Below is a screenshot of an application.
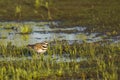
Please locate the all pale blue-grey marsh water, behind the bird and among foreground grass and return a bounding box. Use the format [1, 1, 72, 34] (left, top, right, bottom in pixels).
[0, 21, 120, 62]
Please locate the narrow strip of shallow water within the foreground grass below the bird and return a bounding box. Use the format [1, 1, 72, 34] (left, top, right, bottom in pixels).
[0, 55, 87, 63]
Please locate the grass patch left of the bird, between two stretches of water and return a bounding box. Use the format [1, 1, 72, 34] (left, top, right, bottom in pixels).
[0, 42, 29, 57]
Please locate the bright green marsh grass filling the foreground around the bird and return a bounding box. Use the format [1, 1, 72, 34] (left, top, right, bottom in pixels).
[0, 41, 120, 80]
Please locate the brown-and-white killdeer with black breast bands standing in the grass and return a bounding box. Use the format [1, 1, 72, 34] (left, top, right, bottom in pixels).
[27, 42, 48, 53]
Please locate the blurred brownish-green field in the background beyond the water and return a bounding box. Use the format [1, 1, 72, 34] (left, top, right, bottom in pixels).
[0, 0, 120, 35]
